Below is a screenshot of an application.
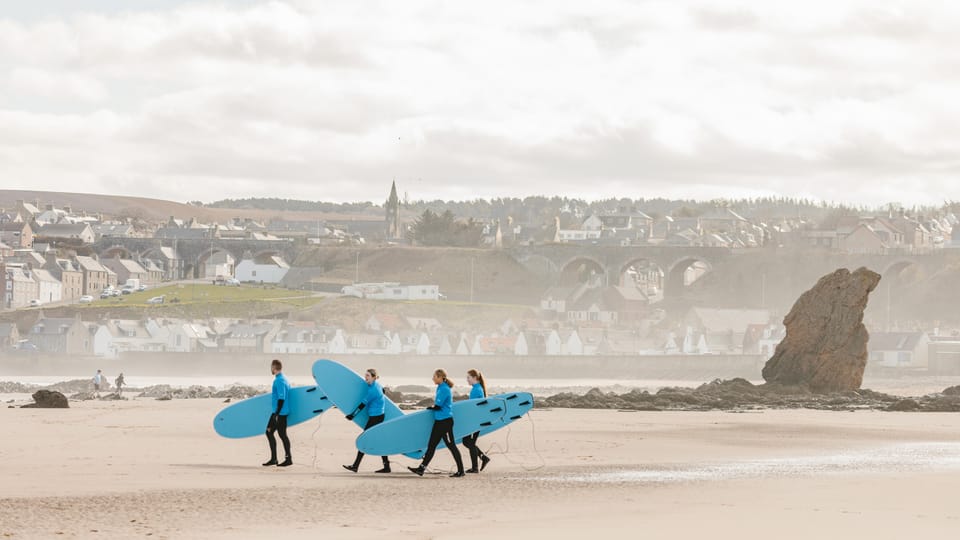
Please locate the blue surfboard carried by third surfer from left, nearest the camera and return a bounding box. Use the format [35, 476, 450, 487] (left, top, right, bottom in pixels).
[357, 397, 507, 456]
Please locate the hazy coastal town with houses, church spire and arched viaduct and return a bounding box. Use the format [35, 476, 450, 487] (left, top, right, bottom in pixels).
[0, 184, 960, 374]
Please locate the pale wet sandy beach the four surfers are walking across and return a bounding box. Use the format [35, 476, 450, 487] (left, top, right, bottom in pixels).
[0, 399, 960, 538]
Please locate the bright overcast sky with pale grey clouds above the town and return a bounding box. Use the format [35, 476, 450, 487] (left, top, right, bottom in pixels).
[0, 0, 960, 205]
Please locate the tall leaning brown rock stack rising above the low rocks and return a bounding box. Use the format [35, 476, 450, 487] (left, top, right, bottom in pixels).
[763, 268, 880, 393]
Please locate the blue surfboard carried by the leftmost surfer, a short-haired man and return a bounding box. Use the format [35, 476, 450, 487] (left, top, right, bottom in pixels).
[213, 386, 333, 439]
